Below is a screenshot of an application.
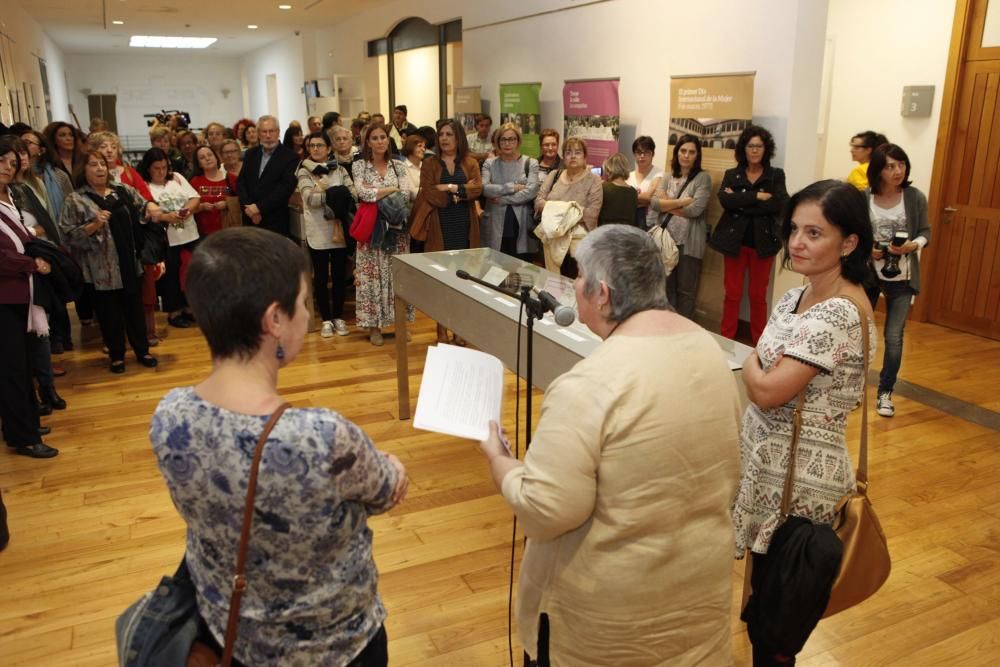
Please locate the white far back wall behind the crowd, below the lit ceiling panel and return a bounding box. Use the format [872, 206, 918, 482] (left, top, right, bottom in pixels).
[67, 49, 243, 138]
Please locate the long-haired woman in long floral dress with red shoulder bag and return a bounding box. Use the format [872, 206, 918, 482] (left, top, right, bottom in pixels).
[352, 124, 415, 345]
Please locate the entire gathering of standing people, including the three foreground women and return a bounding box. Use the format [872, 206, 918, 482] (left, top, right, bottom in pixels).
[0, 100, 930, 664]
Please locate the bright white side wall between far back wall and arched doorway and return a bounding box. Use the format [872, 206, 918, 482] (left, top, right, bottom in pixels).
[242, 35, 304, 131]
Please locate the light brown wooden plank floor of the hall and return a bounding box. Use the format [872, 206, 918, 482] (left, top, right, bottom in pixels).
[0, 316, 1000, 667]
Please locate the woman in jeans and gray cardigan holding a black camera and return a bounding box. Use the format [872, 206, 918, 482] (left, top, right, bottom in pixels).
[865, 143, 931, 417]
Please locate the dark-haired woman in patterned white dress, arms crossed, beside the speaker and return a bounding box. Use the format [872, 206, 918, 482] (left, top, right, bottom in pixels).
[732, 181, 875, 665]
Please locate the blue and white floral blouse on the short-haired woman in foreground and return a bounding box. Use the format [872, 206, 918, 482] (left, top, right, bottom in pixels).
[149, 387, 396, 667]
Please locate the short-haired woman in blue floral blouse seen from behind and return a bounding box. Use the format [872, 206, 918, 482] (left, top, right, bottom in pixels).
[150, 227, 408, 667]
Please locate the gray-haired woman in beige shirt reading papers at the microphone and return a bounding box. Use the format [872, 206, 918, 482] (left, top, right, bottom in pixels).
[481, 225, 740, 666]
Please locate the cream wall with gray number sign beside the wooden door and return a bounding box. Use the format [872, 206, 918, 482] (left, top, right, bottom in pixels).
[823, 0, 952, 193]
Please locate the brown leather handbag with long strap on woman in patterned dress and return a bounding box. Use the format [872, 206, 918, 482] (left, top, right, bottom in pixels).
[823, 297, 892, 618]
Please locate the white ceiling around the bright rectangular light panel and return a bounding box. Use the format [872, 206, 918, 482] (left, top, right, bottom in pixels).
[19, 0, 374, 56]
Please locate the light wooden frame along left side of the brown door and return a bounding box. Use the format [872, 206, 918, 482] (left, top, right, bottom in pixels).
[913, 0, 1000, 322]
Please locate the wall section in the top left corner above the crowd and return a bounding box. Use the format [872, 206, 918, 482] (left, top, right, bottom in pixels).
[0, 3, 70, 128]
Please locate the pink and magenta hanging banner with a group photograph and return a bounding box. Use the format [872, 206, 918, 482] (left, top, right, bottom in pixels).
[563, 79, 621, 167]
